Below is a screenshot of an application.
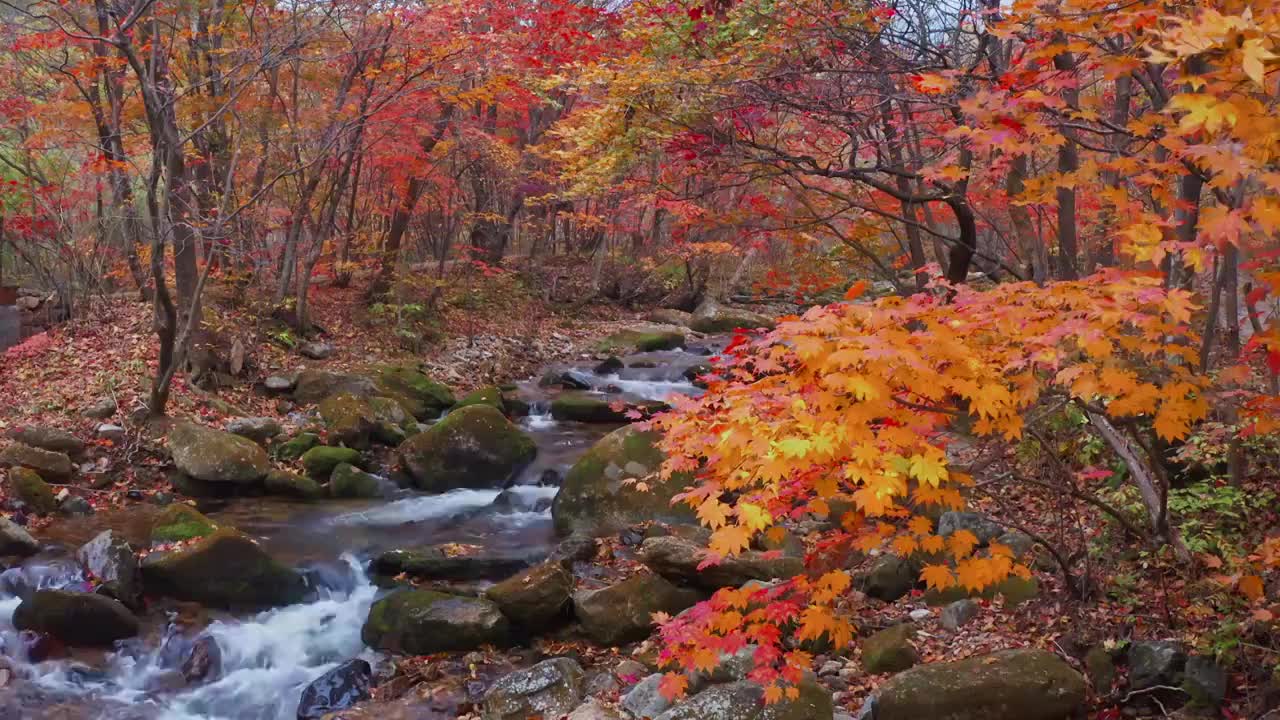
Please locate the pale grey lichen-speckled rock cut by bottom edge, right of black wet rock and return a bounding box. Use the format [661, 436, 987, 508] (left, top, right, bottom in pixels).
[480, 657, 584, 720]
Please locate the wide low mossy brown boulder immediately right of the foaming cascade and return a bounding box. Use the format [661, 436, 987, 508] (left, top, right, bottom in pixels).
[360, 589, 511, 655]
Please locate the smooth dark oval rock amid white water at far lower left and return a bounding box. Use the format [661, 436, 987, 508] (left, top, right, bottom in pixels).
[13, 591, 138, 647]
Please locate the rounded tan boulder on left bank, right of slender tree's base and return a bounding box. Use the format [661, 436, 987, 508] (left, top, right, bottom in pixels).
[169, 423, 271, 484]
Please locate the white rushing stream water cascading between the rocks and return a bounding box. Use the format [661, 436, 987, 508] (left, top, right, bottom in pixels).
[0, 338, 710, 720]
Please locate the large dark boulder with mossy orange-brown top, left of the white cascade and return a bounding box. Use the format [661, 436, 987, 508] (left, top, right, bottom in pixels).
[142, 528, 307, 610]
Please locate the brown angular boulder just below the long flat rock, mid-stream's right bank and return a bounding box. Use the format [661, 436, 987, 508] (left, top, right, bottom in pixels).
[573, 573, 703, 646]
